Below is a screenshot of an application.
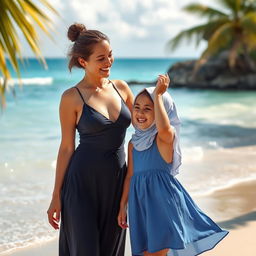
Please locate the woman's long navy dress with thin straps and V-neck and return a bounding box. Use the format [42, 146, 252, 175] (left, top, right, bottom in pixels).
[59, 83, 131, 256]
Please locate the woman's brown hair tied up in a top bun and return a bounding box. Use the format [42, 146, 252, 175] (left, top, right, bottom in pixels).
[67, 23, 109, 71]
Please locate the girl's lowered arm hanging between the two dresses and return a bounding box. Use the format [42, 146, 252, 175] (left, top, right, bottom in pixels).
[117, 142, 133, 228]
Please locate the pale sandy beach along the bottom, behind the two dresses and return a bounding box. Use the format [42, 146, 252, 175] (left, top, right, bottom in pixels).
[1, 178, 256, 256]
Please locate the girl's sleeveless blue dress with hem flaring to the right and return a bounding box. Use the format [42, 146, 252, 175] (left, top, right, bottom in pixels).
[128, 139, 228, 256]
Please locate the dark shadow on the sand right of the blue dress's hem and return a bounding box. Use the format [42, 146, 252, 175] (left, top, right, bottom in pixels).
[218, 211, 256, 230]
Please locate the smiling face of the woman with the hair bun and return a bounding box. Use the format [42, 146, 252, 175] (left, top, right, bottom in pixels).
[85, 40, 114, 78]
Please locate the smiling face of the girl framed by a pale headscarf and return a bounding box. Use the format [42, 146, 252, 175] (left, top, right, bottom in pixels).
[132, 94, 155, 130]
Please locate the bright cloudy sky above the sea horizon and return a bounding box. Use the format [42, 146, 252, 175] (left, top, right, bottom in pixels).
[21, 0, 219, 58]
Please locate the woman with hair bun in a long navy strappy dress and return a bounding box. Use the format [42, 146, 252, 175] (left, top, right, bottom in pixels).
[47, 24, 133, 256]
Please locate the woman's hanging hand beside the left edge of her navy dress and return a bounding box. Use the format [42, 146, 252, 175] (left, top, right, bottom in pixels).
[47, 196, 61, 229]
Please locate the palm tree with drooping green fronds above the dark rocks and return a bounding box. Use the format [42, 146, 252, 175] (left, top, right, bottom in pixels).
[167, 0, 256, 71]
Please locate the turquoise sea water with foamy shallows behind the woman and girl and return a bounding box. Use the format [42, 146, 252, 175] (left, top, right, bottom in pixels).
[0, 59, 256, 254]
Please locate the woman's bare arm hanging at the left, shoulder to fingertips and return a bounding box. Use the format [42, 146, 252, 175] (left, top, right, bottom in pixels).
[47, 89, 76, 229]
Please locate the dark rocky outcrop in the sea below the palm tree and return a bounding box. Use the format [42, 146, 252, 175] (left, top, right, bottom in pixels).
[168, 54, 256, 90]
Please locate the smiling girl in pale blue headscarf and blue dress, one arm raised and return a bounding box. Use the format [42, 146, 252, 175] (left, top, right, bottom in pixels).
[118, 75, 228, 256]
